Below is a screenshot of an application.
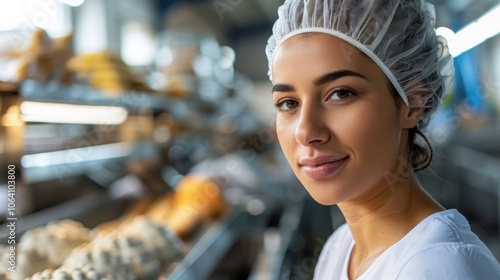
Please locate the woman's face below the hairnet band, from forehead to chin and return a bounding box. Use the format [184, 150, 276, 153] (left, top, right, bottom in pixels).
[273, 33, 407, 205]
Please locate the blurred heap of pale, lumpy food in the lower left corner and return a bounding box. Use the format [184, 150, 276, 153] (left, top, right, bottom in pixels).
[0, 216, 184, 280]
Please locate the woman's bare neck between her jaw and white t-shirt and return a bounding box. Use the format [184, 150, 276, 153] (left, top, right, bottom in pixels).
[338, 175, 444, 276]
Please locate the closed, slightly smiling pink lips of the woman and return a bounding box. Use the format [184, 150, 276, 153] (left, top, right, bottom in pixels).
[299, 156, 349, 180]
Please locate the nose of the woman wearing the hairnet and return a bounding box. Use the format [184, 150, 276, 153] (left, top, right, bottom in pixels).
[295, 104, 330, 146]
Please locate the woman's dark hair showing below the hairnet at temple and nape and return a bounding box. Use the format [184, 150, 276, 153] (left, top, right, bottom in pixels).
[388, 81, 434, 172]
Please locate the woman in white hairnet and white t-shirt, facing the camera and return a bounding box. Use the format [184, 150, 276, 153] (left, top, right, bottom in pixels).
[266, 0, 500, 280]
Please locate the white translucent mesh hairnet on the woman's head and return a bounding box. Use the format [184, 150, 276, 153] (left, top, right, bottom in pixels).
[266, 0, 454, 129]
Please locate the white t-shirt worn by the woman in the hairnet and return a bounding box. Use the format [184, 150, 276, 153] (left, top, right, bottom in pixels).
[314, 210, 500, 280]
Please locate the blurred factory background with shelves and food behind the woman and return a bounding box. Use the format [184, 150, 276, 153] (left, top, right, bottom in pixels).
[0, 0, 500, 279]
